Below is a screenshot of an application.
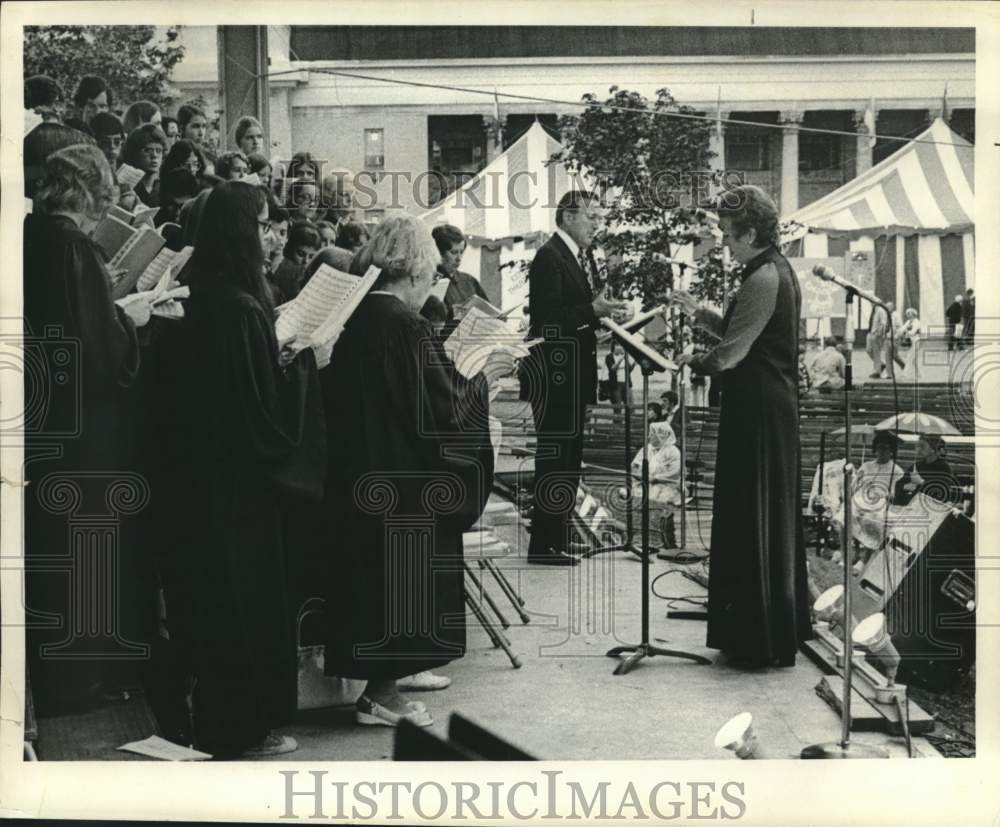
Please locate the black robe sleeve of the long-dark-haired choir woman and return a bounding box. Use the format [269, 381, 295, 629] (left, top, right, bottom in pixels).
[217, 303, 326, 500]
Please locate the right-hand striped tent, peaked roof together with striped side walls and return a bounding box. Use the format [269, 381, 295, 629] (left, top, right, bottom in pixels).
[784, 118, 975, 330]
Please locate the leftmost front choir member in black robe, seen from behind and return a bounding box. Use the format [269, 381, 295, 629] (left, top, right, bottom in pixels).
[23, 142, 156, 715]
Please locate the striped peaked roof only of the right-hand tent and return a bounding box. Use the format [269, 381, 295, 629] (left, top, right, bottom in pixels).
[785, 118, 975, 237]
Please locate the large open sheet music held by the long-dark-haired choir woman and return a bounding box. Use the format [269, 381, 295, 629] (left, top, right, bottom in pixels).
[274, 264, 379, 344]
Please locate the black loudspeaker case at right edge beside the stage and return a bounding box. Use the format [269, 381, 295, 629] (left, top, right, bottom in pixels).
[876, 504, 976, 689]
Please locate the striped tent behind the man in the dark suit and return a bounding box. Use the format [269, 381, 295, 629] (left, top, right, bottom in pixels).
[421, 121, 581, 309]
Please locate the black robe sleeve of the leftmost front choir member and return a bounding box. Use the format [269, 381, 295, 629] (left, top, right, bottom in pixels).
[61, 236, 139, 392]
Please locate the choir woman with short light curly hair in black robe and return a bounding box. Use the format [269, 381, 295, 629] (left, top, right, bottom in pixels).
[320, 215, 493, 725]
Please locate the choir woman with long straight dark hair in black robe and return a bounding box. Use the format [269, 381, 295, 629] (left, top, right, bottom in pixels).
[166, 181, 326, 758]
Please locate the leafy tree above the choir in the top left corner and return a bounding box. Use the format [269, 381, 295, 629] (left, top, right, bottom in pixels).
[24, 26, 184, 111]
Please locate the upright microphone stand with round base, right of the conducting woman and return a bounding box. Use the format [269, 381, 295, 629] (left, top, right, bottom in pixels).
[800, 288, 889, 758]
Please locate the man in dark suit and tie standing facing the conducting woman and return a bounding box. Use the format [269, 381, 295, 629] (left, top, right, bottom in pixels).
[528, 191, 627, 565]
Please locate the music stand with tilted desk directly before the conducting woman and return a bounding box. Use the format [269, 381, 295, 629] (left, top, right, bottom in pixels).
[603, 319, 711, 675]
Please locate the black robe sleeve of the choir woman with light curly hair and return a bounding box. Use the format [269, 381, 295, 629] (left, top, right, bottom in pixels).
[384, 318, 493, 530]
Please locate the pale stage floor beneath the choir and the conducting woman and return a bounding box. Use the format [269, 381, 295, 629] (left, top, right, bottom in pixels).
[278, 512, 939, 761]
